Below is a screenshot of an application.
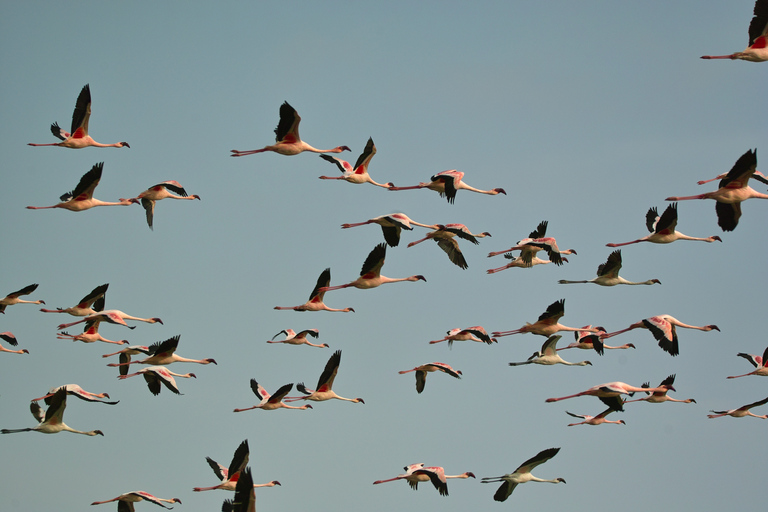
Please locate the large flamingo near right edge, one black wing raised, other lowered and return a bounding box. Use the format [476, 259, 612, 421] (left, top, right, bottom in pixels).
[666, 149, 768, 231]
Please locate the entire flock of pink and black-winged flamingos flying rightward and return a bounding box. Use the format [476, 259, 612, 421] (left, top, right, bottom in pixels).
[0, 0, 768, 512]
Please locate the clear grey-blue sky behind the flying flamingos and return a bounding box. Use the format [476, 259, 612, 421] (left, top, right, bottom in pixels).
[0, 0, 768, 512]
